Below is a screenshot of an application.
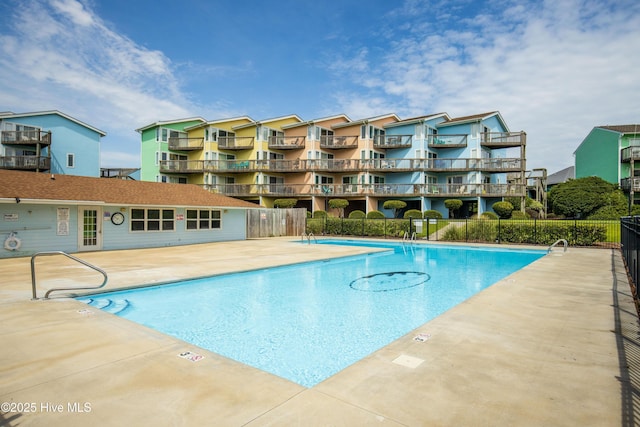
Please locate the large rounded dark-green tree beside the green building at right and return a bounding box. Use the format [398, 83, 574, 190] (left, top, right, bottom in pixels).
[548, 176, 626, 218]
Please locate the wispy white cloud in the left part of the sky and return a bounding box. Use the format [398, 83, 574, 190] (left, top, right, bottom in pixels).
[0, 0, 197, 167]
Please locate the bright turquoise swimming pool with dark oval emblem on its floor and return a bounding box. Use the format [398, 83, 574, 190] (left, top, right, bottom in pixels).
[78, 240, 546, 387]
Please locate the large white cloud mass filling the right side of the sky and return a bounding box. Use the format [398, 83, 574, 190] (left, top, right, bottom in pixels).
[339, 0, 640, 173]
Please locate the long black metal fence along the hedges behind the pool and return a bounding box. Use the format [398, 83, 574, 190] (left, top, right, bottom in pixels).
[306, 217, 620, 248]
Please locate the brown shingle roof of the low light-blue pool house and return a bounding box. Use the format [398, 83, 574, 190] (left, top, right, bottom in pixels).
[0, 169, 259, 208]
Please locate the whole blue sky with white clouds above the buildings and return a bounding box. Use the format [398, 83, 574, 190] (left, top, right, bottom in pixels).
[0, 0, 640, 173]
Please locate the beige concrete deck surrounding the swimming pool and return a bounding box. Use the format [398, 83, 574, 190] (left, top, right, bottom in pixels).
[0, 238, 640, 426]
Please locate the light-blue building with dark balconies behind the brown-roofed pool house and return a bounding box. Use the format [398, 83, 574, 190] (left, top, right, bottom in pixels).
[0, 110, 106, 177]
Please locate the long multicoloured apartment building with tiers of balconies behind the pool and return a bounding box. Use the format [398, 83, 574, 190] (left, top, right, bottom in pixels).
[138, 111, 526, 216]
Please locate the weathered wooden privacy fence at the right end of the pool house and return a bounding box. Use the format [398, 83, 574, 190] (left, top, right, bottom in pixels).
[247, 208, 307, 239]
